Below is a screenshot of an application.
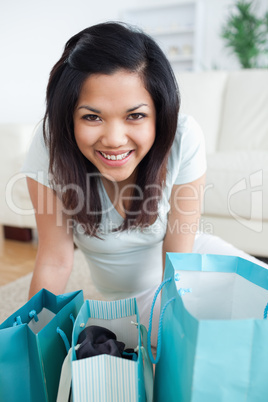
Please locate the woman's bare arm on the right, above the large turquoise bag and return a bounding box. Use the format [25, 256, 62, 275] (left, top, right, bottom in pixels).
[163, 175, 205, 267]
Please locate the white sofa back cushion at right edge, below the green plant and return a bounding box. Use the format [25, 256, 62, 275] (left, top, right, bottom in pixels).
[219, 70, 268, 151]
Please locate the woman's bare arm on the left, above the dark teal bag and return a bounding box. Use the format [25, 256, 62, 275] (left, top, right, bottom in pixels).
[27, 178, 74, 297]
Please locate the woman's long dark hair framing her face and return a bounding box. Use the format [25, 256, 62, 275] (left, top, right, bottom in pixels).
[43, 22, 180, 237]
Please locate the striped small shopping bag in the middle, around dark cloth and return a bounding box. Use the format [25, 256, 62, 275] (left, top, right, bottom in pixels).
[57, 298, 153, 402]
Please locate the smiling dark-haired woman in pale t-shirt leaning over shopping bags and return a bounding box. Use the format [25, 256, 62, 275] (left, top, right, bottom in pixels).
[23, 23, 264, 346]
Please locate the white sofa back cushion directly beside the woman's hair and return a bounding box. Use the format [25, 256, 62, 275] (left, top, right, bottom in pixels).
[176, 71, 227, 154]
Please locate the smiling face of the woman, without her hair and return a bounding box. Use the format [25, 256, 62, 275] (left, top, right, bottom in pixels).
[73, 70, 156, 183]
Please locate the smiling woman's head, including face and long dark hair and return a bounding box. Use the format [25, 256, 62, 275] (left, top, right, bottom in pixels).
[39, 23, 179, 236]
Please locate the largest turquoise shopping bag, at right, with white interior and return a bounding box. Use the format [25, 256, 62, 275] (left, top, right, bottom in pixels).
[148, 253, 268, 402]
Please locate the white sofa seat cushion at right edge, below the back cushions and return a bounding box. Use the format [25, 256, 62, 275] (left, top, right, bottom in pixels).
[203, 151, 268, 221]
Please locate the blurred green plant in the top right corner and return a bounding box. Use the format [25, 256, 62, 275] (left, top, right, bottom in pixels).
[221, 0, 268, 68]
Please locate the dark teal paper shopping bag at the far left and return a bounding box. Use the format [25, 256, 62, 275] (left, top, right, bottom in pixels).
[0, 289, 83, 402]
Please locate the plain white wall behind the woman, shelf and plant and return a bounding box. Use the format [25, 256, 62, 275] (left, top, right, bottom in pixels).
[0, 0, 268, 123]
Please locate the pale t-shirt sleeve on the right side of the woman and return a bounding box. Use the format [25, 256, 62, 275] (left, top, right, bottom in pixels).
[171, 116, 207, 185]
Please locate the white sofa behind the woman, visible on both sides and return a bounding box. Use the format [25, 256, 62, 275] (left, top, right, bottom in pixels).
[0, 70, 268, 257]
